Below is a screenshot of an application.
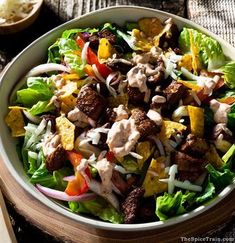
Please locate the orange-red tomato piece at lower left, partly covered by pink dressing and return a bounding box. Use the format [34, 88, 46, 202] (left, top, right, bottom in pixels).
[65, 151, 91, 196]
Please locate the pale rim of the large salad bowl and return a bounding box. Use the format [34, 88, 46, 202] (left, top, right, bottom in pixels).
[0, 5, 235, 232]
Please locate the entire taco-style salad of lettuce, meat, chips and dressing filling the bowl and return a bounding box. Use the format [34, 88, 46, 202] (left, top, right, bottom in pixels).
[5, 17, 235, 224]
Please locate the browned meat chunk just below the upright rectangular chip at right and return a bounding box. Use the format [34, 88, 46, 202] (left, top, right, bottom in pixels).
[180, 134, 209, 157]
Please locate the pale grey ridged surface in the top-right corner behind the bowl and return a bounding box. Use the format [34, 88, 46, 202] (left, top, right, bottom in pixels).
[187, 0, 235, 47]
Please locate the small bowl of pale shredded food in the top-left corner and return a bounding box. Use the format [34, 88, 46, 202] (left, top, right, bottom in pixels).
[0, 0, 43, 35]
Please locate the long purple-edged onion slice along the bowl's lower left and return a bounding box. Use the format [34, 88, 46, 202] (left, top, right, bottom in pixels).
[36, 184, 97, 202]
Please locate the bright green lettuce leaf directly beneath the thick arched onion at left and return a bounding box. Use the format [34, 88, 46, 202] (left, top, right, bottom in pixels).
[16, 77, 53, 107]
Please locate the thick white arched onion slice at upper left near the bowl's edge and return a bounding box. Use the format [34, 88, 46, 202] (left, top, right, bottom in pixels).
[26, 63, 70, 77]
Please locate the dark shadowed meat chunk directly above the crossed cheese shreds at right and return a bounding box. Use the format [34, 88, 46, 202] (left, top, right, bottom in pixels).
[174, 152, 205, 182]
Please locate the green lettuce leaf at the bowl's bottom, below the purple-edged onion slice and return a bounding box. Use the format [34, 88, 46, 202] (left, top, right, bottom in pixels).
[69, 197, 124, 224]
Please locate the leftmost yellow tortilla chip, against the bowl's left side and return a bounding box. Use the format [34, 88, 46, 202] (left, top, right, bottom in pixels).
[5, 106, 25, 137]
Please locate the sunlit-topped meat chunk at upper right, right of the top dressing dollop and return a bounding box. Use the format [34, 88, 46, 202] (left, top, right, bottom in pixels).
[164, 81, 187, 105]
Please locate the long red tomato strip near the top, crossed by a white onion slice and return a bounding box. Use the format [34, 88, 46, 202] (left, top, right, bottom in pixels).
[76, 36, 112, 78]
